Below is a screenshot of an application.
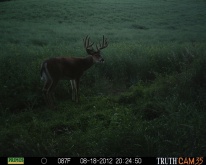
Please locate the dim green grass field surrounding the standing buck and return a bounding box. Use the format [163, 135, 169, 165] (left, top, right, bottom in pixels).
[0, 0, 206, 157]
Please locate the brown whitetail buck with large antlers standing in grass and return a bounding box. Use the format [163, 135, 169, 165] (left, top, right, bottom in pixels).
[41, 36, 108, 106]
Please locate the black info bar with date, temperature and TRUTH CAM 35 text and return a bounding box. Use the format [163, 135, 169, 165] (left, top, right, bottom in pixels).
[0, 157, 206, 165]
